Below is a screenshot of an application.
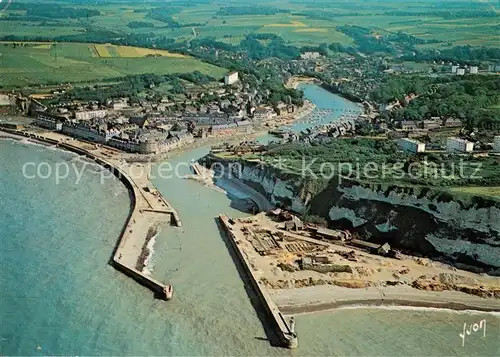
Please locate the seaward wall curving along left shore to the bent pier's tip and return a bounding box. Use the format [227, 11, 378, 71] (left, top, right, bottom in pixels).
[1, 128, 177, 298]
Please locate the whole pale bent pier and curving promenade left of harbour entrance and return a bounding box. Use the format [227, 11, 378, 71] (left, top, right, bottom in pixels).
[1, 128, 182, 300]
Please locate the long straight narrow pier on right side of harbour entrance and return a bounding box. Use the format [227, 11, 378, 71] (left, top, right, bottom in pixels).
[219, 215, 299, 349]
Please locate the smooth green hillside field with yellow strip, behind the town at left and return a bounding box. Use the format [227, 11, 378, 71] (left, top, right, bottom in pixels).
[0, 42, 226, 87]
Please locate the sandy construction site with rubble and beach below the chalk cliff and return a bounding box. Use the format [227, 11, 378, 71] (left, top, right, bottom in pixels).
[226, 209, 500, 314]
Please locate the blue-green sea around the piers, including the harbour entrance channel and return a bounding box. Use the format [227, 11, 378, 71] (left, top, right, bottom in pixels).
[0, 85, 500, 356]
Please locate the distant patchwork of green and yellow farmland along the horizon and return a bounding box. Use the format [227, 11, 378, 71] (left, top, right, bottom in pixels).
[0, 0, 500, 48]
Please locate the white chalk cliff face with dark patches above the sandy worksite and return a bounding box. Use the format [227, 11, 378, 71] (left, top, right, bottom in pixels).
[203, 154, 500, 274]
